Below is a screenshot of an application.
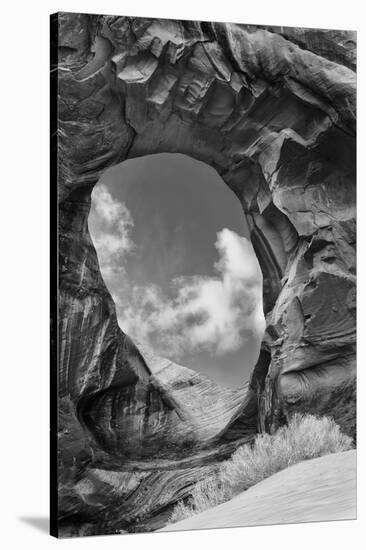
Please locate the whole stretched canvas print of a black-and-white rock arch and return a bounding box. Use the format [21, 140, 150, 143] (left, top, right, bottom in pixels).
[51, 13, 356, 537]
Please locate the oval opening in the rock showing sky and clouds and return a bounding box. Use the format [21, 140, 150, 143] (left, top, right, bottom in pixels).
[88, 153, 265, 388]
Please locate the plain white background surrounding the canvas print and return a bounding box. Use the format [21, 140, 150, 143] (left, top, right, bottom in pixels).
[0, 0, 366, 550]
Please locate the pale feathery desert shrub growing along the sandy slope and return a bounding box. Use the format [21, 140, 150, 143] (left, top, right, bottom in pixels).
[170, 414, 352, 523]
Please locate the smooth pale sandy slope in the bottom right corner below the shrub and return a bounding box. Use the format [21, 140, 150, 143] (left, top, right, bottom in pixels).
[162, 451, 356, 531]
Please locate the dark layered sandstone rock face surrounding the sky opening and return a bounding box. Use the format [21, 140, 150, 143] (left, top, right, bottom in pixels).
[56, 13, 356, 535]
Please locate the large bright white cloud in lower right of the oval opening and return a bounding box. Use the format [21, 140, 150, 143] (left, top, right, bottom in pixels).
[119, 228, 264, 359]
